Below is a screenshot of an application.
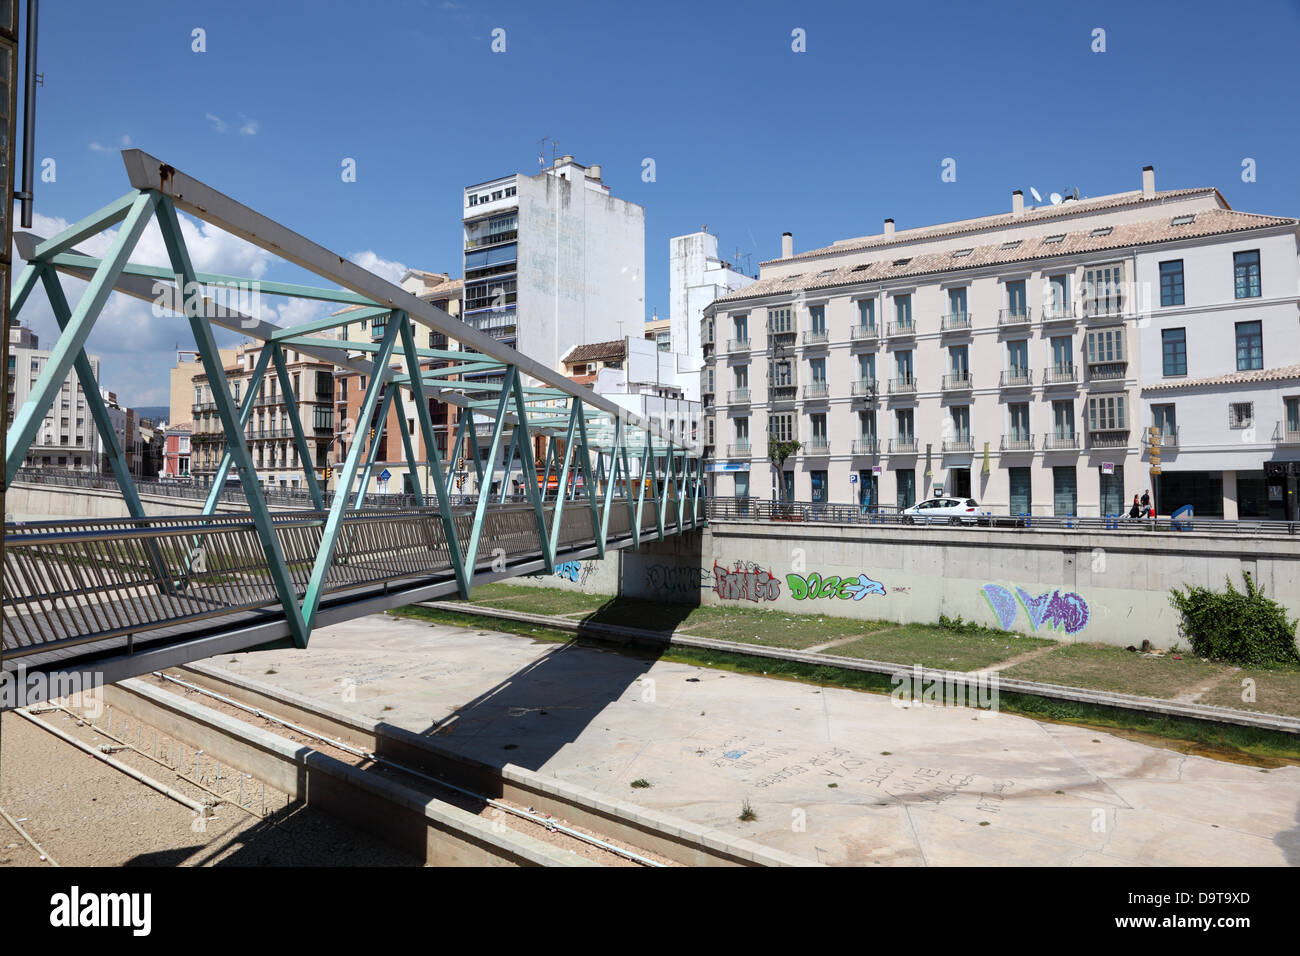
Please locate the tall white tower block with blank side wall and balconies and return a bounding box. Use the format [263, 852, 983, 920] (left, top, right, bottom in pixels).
[462, 156, 645, 380]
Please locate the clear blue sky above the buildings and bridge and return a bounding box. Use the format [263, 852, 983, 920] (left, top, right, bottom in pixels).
[12, 0, 1300, 405]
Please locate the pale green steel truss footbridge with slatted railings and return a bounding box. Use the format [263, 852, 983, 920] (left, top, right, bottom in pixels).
[3, 150, 705, 706]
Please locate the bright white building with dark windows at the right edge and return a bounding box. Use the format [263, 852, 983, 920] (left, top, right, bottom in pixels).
[1138, 230, 1300, 520]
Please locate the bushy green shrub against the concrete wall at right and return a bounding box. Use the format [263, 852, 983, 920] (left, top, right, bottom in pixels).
[1169, 572, 1300, 667]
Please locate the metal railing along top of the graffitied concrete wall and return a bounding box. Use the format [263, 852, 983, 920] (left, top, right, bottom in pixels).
[705, 498, 1300, 537]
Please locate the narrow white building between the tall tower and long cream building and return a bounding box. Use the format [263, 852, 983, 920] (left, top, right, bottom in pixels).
[668, 229, 755, 402]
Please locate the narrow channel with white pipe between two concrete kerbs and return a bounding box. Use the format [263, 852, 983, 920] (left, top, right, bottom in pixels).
[142, 671, 679, 868]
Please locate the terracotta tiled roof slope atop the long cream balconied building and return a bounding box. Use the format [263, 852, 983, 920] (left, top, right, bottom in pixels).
[718, 209, 1300, 302]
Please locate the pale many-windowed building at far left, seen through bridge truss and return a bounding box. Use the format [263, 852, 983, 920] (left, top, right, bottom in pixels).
[5, 321, 104, 472]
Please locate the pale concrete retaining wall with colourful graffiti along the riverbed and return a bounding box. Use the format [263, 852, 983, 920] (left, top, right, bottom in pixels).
[499, 522, 1300, 648]
